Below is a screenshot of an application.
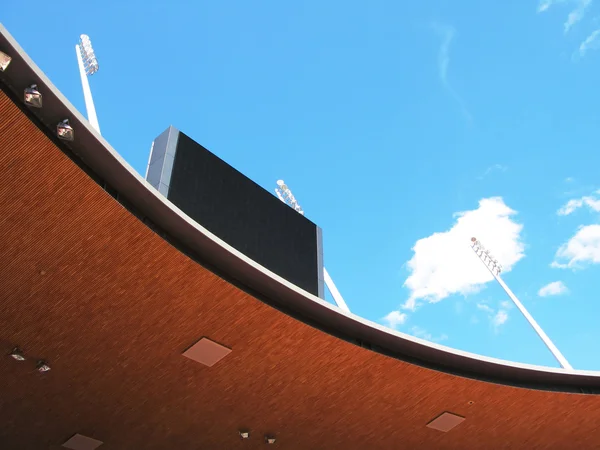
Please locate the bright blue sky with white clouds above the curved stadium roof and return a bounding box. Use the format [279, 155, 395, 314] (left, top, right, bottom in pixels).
[2, 0, 600, 370]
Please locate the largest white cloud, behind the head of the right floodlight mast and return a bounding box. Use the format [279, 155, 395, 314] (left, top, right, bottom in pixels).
[403, 197, 525, 310]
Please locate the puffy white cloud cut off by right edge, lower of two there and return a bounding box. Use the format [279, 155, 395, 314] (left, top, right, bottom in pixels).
[551, 225, 600, 269]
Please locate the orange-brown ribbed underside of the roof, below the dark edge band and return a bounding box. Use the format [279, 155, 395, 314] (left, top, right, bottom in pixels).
[0, 89, 600, 450]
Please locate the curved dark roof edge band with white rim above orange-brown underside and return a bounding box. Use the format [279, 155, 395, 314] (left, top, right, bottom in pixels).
[0, 24, 600, 394]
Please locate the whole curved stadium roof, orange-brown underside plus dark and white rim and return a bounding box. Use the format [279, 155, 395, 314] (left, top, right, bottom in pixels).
[0, 26, 600, 449]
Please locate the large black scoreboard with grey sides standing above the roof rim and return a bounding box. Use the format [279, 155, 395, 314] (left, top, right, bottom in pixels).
[146, 127, 323, 298]
